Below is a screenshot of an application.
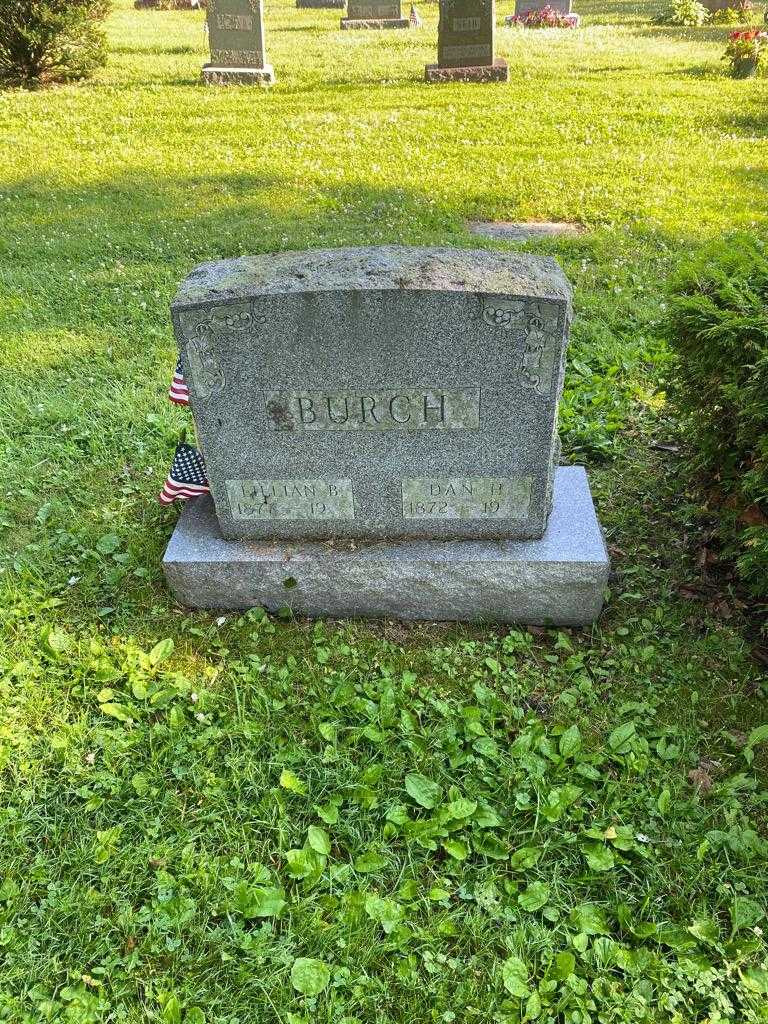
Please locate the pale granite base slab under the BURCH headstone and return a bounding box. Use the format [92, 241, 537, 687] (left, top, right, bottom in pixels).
[163, 466, 608, 626]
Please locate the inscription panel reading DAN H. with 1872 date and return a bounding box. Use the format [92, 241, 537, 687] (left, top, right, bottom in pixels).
[401, 476, 532, 519]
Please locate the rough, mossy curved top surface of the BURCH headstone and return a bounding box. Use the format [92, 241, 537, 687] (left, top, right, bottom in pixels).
[173, 246, 571, 309]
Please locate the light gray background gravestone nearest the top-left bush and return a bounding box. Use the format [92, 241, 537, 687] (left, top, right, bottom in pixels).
[203, 0, 274, 85]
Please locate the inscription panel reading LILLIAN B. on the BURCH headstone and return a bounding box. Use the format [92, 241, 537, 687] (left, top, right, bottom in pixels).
[226, 479, 354, 520]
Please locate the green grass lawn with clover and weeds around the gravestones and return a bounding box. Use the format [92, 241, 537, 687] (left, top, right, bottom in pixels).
[0, 0, 768, 1024]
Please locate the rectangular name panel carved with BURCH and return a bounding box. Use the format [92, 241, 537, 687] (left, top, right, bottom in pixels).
[265, 388, 480, 431]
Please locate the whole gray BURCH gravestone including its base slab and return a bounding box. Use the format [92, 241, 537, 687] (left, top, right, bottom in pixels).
[164, 246, 607, 625]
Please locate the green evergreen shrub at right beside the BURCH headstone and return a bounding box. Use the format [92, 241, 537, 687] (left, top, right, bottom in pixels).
[668, 234, 768, 595]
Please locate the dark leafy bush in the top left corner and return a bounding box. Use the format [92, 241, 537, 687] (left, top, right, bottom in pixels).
[0, 0, 111, 87]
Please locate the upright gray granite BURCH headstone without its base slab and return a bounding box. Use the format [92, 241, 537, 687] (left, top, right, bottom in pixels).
[172, 246, 571, 541]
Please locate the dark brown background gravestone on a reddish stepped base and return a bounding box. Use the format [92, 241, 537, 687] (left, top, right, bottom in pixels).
[425, 0, 509, 82]
